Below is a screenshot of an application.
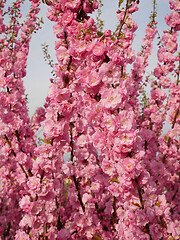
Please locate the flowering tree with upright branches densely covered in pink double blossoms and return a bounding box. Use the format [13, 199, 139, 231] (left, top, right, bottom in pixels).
[0, 0, 180, 240]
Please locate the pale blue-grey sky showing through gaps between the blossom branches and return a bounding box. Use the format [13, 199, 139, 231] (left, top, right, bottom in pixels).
[24, 0, 170, 116]
